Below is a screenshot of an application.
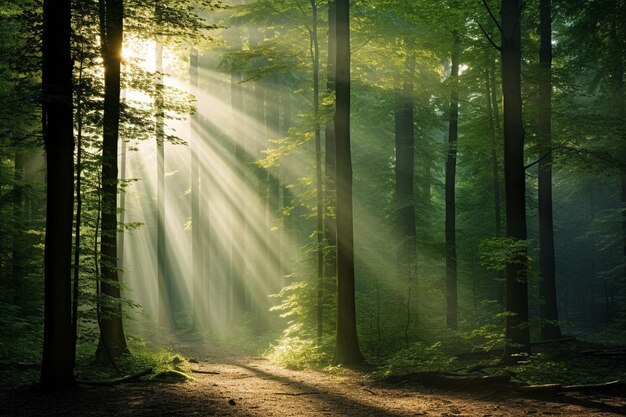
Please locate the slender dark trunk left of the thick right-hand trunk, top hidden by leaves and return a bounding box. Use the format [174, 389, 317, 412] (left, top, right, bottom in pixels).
[445, 32, 461, 329]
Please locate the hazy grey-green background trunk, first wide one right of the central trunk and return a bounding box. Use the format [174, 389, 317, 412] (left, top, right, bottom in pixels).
[394, 54, 416, 344]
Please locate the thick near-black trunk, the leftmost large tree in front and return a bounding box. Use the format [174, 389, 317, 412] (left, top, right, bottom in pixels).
[40, 0, 74, 389]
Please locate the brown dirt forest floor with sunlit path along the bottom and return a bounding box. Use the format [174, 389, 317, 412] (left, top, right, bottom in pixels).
[0, 342, 626, 417]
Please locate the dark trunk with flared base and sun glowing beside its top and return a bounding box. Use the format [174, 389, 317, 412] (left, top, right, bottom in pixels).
[96, 0, 128, 363]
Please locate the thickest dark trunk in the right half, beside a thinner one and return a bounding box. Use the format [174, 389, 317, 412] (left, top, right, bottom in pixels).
[501, 0, 530, 362]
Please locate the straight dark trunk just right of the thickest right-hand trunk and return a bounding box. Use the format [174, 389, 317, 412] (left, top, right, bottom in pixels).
[537, 0, 562, 340]
